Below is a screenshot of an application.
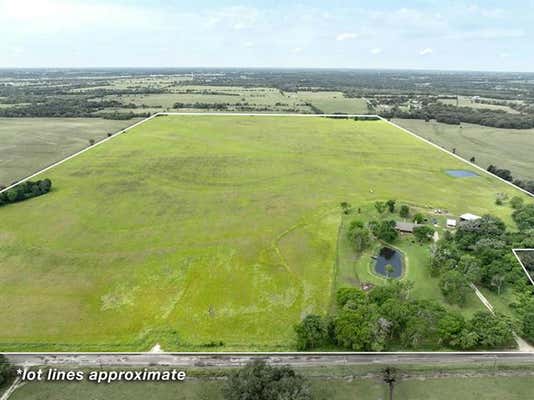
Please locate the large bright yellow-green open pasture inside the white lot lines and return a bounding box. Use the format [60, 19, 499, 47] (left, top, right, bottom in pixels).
[0, 116, 532, 350]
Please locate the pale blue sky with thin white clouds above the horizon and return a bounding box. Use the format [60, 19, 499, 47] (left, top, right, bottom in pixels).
[0, 0, 534, 71]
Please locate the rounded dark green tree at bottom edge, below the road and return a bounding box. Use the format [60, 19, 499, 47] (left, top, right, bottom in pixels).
[222, 360, 312, 400]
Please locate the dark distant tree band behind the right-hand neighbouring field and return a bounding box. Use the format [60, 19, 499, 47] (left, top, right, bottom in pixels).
[382, 102, 534, 129]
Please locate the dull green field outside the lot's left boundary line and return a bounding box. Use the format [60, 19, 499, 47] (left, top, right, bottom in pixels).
[0, 118, 138, 185]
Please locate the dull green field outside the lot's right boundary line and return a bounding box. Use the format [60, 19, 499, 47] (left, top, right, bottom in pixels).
[393, 119, 534, 179]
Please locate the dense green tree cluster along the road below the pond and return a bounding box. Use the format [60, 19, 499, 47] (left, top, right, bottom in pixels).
[295, 281, 514, 351]
